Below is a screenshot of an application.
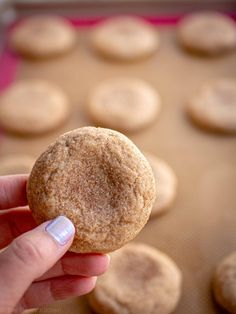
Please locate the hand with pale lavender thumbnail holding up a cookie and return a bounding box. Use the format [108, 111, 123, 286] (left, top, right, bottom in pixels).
[0, 175, 109, 314]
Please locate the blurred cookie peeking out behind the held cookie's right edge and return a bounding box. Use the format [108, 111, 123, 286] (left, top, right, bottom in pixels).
[145, 153, 177, 217]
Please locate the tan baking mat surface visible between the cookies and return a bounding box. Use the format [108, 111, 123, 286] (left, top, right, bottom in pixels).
[1, 26, 236, 314]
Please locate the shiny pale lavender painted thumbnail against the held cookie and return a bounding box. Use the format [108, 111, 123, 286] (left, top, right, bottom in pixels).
[45, 216, 75, 245]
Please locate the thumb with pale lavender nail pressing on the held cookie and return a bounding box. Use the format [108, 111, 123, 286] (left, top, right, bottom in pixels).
[0, 216, 75, 312]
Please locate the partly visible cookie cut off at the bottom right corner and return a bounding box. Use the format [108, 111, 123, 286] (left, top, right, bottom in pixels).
[213, 252, 236, 314]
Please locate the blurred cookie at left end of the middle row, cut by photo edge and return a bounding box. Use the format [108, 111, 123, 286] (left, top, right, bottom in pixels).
[0, 79, 69, 135]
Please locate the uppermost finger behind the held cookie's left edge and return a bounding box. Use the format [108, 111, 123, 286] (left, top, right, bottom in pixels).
[0, 175, 28, 210]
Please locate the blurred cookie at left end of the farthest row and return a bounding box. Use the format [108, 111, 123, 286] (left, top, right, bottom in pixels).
[10, 16, 76, 58]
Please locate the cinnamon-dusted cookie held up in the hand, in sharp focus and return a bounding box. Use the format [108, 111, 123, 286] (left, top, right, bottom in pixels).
[27, 127, 156, 253]
